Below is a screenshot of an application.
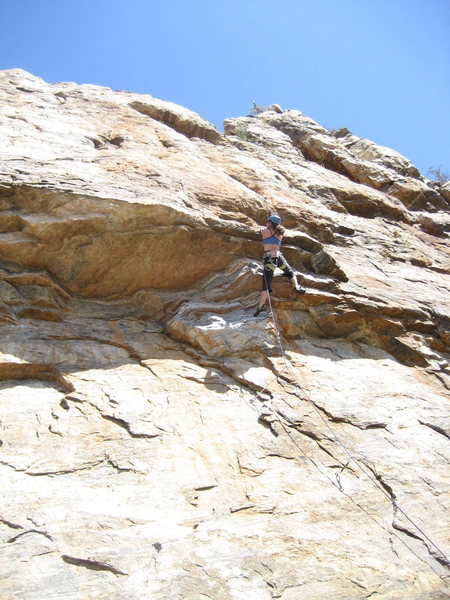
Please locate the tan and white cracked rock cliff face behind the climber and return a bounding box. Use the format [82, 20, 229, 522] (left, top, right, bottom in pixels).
[0, 70, 450, 600]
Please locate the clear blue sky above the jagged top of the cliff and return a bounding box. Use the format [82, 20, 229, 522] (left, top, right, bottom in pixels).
[0, 0, 450, 175]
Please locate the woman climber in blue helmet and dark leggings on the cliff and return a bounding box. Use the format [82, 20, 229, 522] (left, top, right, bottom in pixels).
[253, 215, 306, 317]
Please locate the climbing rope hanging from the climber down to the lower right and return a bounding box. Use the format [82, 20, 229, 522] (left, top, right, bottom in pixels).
[257, 270, 450, 576]
